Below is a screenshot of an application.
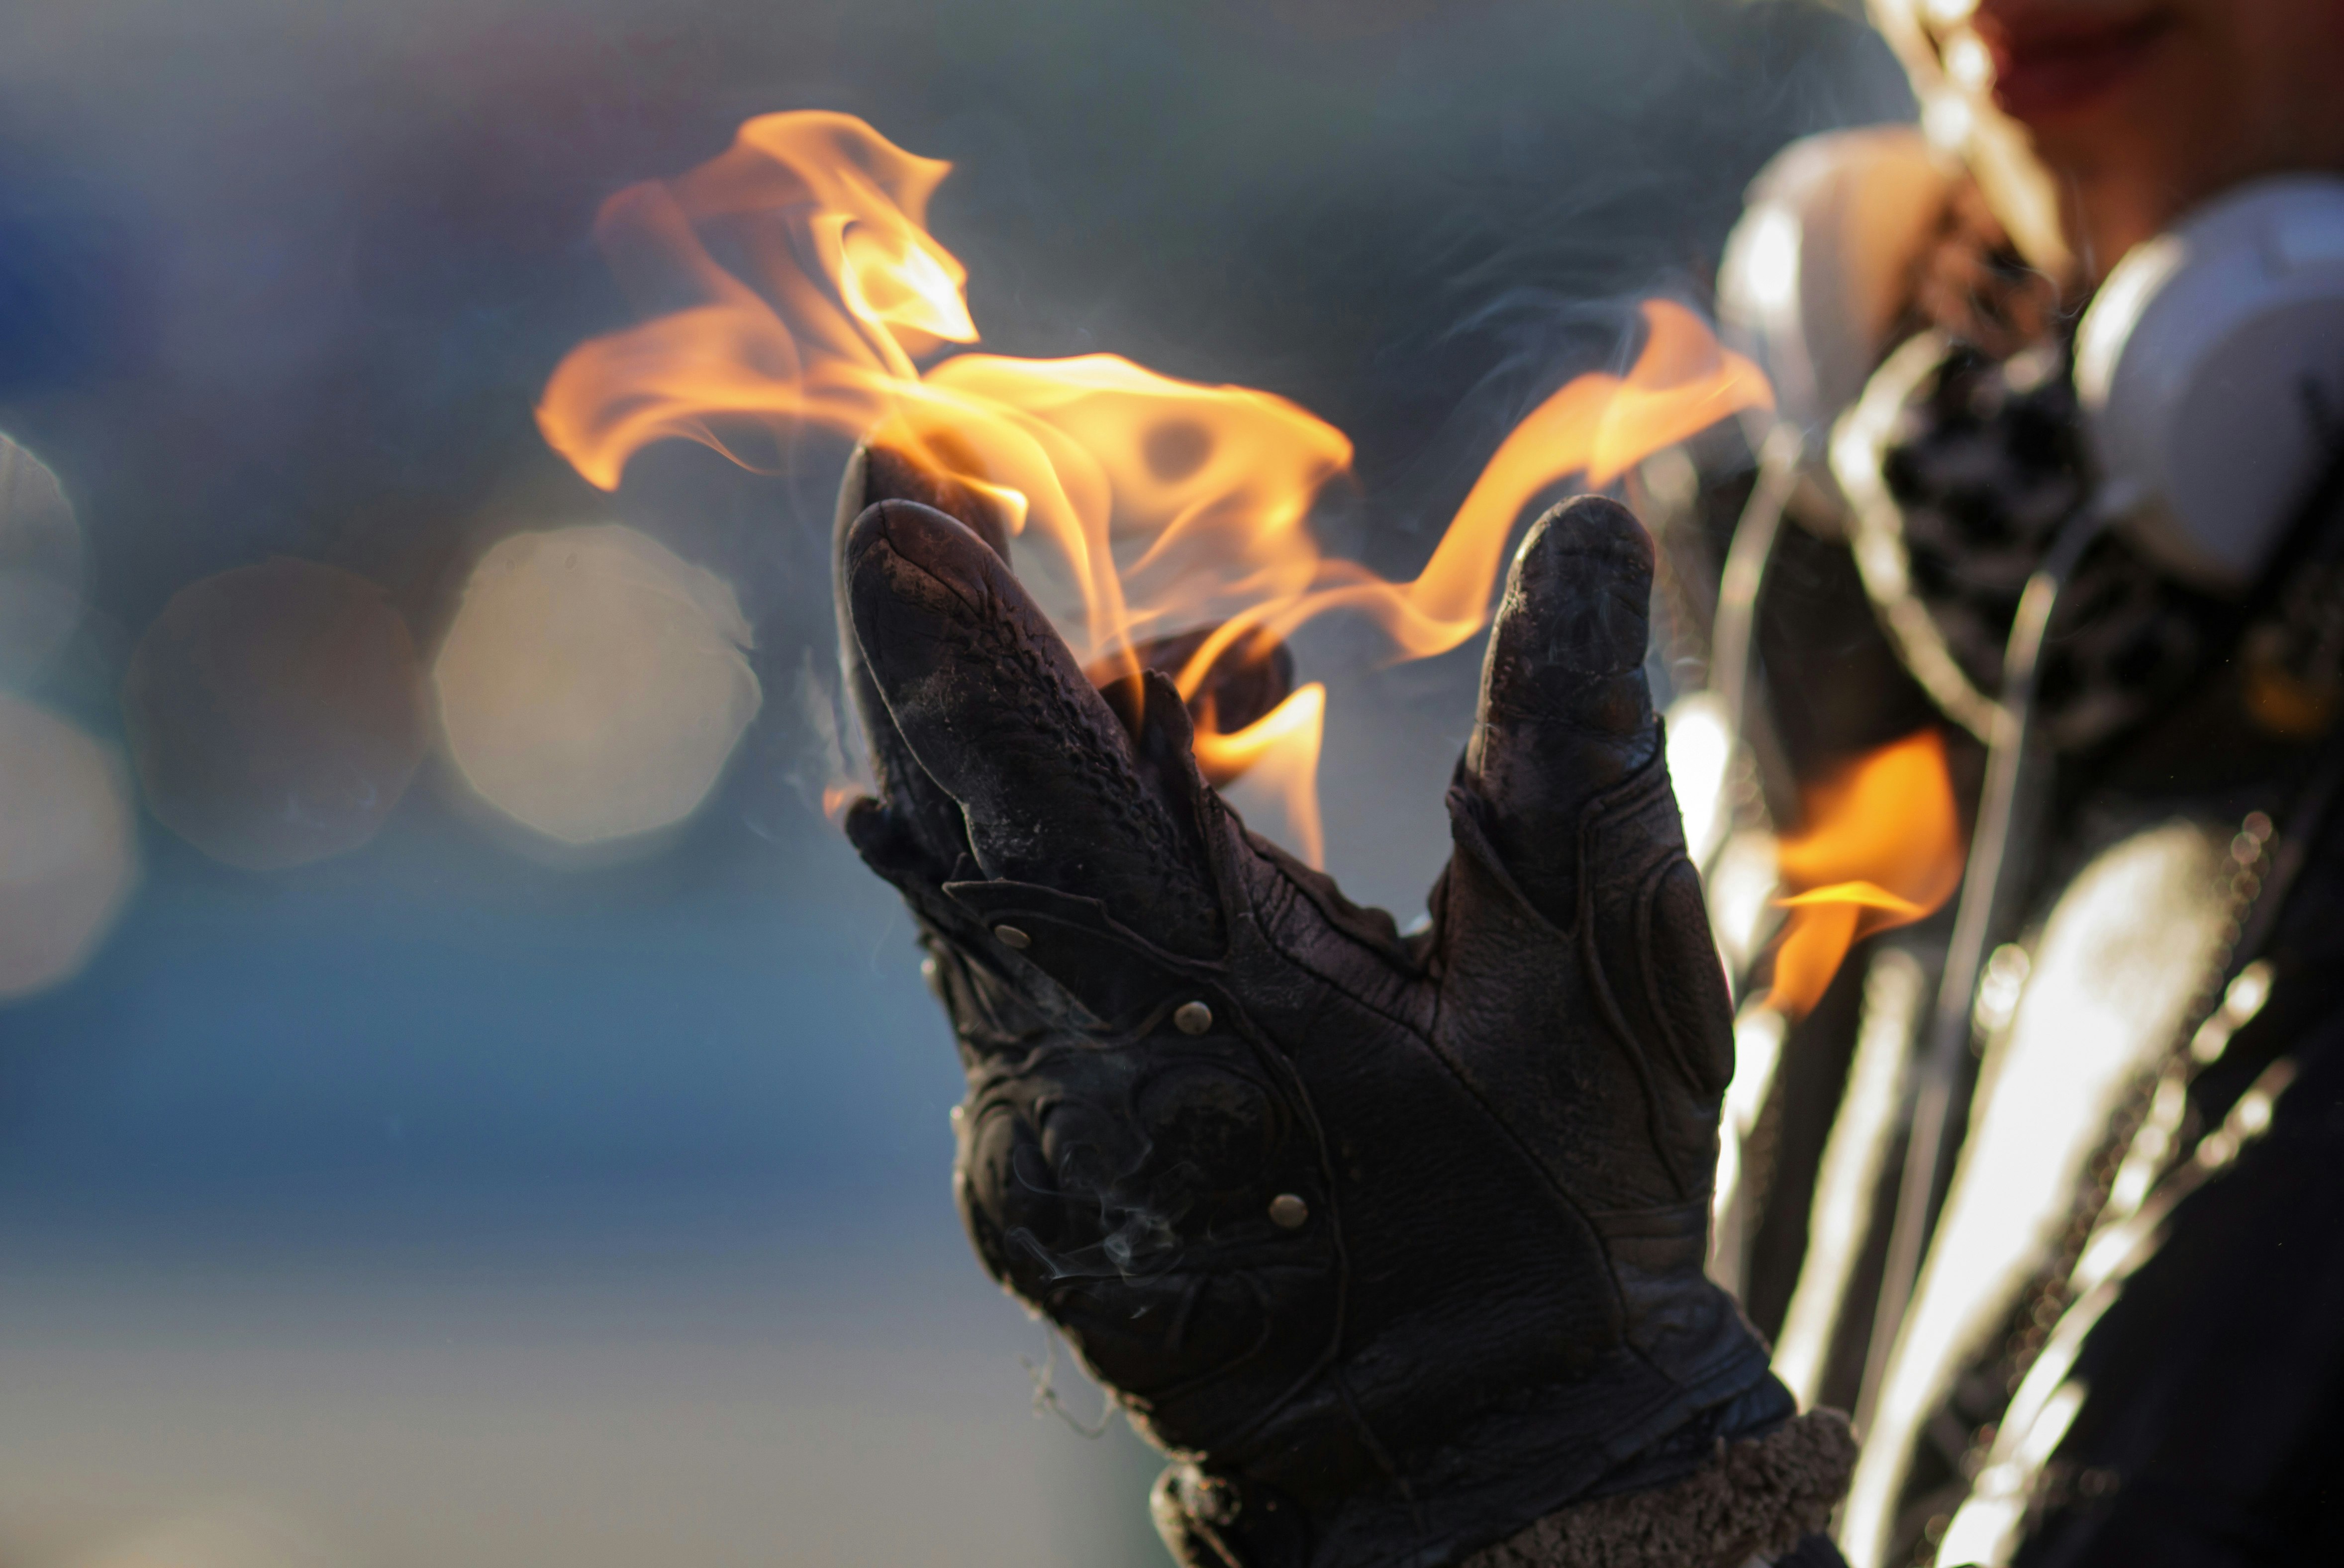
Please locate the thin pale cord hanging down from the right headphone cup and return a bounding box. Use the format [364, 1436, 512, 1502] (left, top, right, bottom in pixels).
[1856, 508, 2107, 1432]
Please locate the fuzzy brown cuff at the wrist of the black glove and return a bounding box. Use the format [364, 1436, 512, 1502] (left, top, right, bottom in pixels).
[1456, 1411, 1856, 1568]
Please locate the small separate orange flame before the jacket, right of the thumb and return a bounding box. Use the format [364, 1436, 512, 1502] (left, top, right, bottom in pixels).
[1767, 729, 1962, 1017]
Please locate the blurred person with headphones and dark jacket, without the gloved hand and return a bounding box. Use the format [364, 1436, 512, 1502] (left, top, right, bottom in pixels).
[1655, 0, 2344, 1568]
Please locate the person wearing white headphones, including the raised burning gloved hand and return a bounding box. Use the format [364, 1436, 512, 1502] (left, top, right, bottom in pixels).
[839, 0, 2344, 1568]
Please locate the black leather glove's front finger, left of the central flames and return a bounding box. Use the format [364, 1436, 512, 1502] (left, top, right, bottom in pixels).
[839, 490, 1219, 954]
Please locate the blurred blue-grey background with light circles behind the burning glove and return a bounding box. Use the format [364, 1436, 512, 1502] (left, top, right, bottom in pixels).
[0, 0, 1910, 1568]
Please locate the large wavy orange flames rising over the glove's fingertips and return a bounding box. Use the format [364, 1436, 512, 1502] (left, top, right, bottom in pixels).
[537, 112, 1772, 863]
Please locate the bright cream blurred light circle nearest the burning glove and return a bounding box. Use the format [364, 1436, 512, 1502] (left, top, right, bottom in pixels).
[431, 523, 762, 844]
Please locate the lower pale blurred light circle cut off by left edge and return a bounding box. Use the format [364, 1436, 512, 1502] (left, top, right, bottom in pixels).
[0, 694, 138, 998]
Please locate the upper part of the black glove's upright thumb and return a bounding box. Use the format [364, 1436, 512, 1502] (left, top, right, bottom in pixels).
[1465, 494, 1660, 928]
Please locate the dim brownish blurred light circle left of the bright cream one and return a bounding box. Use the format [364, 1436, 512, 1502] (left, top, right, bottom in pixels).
[122, 560, 427, 872]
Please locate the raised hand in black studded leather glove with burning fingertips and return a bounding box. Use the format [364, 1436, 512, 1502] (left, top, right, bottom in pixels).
[837, 452, 1828, 1568]
